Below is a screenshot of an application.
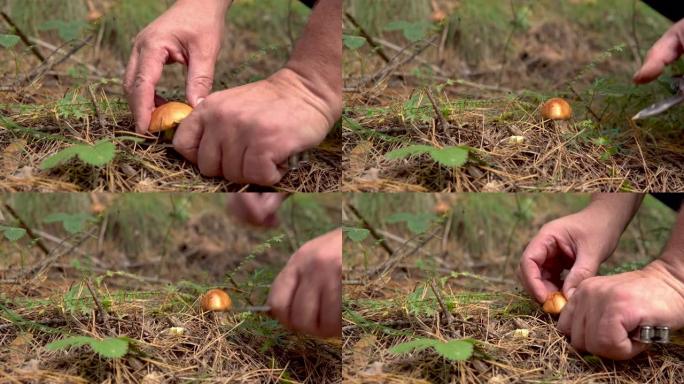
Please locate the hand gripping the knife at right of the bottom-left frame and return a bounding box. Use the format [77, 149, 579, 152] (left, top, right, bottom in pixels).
[268, 229, 342, 337]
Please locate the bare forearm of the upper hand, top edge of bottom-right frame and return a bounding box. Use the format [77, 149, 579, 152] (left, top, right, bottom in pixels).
[584, 193, 645, 236]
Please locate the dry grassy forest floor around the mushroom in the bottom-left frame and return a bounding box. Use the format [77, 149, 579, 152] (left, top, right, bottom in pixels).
[0, 195, 341, 384]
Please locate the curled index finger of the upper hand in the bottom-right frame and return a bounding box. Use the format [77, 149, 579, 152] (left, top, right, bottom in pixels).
[520, 235, 559, 303]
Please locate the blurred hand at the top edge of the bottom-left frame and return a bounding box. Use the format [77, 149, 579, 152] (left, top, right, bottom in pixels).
[228, 193, 288, 228]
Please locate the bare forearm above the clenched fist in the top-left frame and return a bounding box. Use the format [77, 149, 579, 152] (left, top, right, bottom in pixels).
[286, 0, 342, 119]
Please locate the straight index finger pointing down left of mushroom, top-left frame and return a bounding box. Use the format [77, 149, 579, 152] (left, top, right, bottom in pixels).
[128, 48, 168, 134]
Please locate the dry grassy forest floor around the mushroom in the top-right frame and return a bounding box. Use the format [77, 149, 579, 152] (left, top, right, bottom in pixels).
[342, 0, 684, 192]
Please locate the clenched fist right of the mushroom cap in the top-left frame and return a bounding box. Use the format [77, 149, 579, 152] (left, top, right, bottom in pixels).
[173, 68, 341, 186]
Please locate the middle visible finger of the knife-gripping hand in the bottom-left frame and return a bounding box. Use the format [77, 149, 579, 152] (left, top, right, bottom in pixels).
[290, 276, 323, 337]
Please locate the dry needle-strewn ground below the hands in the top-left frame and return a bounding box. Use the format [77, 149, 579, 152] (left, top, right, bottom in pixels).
[0, 87, 341, 192]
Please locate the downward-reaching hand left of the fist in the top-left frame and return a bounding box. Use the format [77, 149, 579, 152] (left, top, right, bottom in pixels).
[124, 0, 232, 134]
